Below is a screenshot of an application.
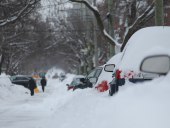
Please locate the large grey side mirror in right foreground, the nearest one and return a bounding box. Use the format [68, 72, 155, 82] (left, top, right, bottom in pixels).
[140, 55, 170, 75]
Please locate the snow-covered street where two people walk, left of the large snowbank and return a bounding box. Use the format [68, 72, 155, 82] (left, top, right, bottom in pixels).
[0, 76, 75, 128]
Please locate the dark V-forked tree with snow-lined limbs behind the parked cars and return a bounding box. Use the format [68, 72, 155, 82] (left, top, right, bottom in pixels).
[70, 0, 154, 51]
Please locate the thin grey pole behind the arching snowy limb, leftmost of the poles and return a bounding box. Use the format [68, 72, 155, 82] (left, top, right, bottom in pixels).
[93, 0, 98, 67]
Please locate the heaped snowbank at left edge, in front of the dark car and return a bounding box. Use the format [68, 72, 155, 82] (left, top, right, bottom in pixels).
[0, 74, 29, 102]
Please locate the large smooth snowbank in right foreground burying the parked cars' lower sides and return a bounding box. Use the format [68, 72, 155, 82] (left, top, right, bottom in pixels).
[42, 73, 170, 128]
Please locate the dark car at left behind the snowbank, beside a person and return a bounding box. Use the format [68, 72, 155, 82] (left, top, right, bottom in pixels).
[10, 75, 33, 88]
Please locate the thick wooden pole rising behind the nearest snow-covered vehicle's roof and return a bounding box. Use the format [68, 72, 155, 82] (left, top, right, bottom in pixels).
[155, 0, 164, 26]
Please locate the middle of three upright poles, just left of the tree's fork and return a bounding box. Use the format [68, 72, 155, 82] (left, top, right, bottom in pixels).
[108, 0, 115, 58]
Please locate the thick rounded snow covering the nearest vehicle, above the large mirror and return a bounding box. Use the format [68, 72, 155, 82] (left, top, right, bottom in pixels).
[119, 26, 170, 71]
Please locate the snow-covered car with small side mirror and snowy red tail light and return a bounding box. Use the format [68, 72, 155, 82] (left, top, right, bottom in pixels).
[69, 53, 122, 92]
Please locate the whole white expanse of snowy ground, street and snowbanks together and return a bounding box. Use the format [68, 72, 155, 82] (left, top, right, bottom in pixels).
[0, 71, 170, 128]
